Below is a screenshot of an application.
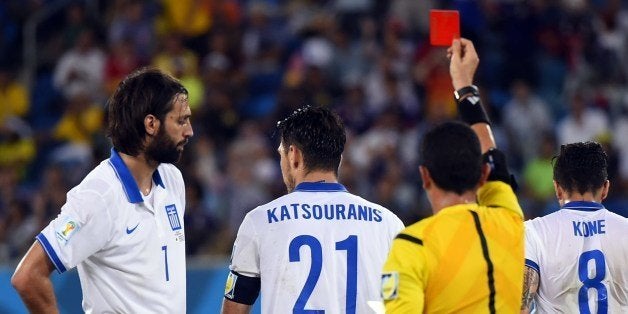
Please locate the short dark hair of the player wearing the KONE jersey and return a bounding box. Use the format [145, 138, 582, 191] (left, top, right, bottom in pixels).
[552, 142, 608, 194]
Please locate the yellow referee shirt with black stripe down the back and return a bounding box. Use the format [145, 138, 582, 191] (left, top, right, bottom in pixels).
[382, 181, 524, 313]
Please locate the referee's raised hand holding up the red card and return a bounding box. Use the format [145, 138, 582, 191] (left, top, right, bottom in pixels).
[447, 38, 480, 90]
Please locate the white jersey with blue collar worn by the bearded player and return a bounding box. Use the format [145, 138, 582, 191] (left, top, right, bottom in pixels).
[37, 150, 186, 313]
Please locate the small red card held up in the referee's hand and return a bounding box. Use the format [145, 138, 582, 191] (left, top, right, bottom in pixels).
[430, 10, 460, 47]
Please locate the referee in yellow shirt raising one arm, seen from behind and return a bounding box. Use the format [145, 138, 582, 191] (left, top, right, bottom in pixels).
[382, 39, 524, 313]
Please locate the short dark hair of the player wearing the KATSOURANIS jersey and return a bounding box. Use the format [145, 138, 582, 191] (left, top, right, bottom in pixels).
[277, 106, 347, 176]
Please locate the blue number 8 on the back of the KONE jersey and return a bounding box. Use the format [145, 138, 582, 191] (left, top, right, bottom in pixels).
[578, 250, 608, 314]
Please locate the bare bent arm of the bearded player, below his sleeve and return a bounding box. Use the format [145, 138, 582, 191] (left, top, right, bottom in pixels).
[11, 242, 58, 313]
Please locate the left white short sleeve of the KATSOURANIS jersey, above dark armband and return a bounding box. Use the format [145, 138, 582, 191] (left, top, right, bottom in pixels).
[229, 214, 260, 277]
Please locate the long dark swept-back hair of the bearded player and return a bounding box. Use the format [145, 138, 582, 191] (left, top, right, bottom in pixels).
[107, 68, 188, 156]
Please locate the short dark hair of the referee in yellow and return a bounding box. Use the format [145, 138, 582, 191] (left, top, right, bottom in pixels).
[420, 121, 483, 194]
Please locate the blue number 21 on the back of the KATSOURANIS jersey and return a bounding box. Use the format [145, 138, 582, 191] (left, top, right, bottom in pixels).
[288, 235, 358, 314]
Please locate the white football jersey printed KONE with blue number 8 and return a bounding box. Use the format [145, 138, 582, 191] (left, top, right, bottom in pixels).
[525, 202, 628, 313]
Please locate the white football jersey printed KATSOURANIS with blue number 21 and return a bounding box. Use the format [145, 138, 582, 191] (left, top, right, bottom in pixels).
[226, 182, 403, 314]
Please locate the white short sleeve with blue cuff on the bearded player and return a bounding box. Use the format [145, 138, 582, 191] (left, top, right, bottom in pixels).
[37, 190, 112, 273]
